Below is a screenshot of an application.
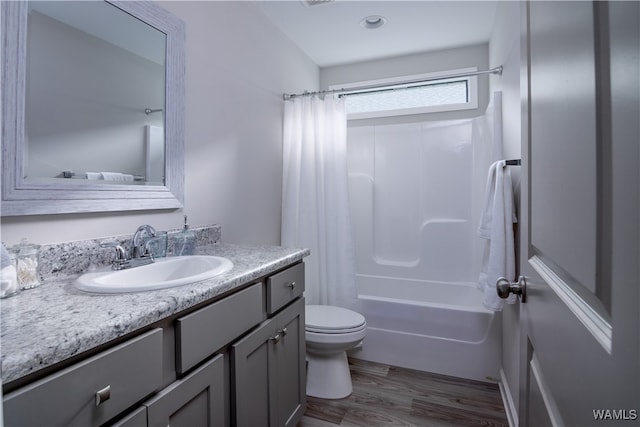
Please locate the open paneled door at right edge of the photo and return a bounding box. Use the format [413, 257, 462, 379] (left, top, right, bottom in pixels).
[519, 1, 640, 427]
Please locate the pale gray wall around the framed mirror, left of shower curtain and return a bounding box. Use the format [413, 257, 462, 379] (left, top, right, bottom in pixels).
[1, 1, 319, 244]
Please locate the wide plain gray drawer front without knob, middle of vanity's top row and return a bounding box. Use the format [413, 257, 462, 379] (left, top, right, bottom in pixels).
[176, 283, 264, 374]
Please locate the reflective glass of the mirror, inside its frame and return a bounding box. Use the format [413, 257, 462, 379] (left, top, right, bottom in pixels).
[23, 1, 166, 185]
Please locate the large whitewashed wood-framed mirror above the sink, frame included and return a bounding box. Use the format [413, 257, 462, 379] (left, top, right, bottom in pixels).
[0, 0, 185, 216]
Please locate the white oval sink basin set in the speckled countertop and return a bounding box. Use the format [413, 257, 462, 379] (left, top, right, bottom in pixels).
[74, 255, 233, 294]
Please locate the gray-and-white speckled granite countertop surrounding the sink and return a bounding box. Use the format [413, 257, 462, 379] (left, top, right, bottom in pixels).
[0, 243, 309, 384]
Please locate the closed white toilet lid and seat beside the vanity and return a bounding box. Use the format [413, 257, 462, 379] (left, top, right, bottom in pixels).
[305, 305, 366, 333]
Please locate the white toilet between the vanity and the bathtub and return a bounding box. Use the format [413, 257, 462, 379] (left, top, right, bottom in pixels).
[305, 305, 367, 399]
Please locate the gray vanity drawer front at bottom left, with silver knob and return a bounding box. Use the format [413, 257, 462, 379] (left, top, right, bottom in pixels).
[4, 328, 162, 426]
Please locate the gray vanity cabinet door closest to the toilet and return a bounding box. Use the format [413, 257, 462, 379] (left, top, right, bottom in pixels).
[273, 298, 307, 427]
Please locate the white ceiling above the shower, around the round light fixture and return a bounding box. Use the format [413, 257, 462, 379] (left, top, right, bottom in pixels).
[257, 0, 497, 67]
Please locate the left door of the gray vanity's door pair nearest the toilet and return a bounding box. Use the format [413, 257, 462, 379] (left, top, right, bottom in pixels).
[231, 319, 278, 427]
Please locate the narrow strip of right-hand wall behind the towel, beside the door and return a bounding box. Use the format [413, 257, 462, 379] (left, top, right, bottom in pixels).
[489, 2, 521, 424]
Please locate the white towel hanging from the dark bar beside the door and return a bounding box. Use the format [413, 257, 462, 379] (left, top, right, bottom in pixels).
[478, 160, 517, 311]
